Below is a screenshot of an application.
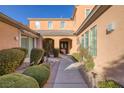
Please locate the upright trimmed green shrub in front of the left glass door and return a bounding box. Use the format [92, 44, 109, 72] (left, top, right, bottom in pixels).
[30, 48, 44, 65]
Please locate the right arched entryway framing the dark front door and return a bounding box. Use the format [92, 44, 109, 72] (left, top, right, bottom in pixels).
[59, 38, 72, 54]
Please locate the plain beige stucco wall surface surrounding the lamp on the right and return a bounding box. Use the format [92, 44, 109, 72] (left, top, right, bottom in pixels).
[79, 6, 124, 85]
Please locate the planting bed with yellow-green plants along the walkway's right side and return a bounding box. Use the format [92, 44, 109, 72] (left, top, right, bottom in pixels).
[70, 48, 123, 88]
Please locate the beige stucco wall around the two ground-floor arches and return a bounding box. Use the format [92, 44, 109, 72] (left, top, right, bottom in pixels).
[43, 36, 77, 54]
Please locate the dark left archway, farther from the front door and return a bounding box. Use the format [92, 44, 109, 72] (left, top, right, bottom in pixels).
[43, 38, 54, 54]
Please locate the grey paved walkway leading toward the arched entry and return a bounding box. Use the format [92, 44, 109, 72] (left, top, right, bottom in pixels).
[45, 56, 87, 88]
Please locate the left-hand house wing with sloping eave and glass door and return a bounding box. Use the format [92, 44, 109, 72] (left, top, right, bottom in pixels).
[0, 13, 42, 54]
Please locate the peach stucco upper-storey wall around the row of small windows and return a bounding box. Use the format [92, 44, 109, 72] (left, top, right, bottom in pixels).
[29, 5, 94, 31]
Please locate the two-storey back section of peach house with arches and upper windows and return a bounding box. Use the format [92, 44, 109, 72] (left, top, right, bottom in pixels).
[28, 5, 93, 54]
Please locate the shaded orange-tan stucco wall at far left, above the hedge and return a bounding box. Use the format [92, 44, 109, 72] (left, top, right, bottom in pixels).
[0, 22, 19, 50]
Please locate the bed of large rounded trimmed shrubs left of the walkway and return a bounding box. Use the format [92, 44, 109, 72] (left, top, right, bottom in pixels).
[0, 48, 50, 88]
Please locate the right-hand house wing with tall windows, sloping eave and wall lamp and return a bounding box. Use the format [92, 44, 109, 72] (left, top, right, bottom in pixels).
[75, 5, 124, 85]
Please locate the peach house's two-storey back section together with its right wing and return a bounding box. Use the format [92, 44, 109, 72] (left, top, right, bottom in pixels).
[28, 5, 124, 85]
